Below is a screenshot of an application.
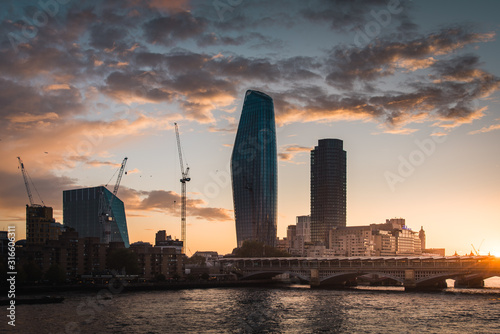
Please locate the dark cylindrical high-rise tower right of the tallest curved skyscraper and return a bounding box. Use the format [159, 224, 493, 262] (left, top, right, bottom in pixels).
[311, 139, 347, 246]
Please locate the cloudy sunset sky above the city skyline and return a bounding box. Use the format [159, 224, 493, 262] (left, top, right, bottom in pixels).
[0, 0, 500, 256]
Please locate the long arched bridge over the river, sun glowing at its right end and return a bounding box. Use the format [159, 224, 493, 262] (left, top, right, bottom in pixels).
[220, 256, 500, 290]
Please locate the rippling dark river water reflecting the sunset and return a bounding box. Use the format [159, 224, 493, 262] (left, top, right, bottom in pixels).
[4, 278, 500, 333]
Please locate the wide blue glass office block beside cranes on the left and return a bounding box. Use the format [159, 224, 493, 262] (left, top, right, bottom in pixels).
[63, 186, 130, 247]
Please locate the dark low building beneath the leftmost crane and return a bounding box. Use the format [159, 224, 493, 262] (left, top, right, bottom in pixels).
[26, 205, 62, 245]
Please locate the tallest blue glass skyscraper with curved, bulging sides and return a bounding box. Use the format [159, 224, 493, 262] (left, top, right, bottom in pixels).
[231, 90, 278, 247]
